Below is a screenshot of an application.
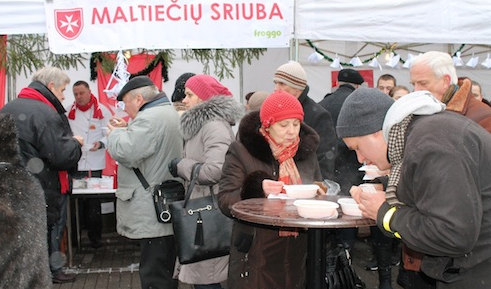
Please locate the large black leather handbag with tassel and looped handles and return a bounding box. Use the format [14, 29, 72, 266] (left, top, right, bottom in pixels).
[170, 164, 233, 264]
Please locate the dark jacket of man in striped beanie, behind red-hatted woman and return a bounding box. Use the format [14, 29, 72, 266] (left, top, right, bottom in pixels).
[298, 86, 337, 180]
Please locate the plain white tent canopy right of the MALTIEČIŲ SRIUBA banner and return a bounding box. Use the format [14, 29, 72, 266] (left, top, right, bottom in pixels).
[295, 0, 491, 44]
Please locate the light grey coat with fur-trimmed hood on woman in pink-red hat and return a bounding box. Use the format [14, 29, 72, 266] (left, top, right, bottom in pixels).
[176, 96, 244, 284]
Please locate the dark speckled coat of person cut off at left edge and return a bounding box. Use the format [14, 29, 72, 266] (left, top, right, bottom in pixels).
[0, 114, 52, 289]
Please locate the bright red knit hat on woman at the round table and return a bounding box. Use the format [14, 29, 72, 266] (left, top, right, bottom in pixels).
[259, 91, 303, 127]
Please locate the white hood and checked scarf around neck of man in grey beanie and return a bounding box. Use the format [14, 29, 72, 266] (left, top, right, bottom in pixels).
[382, 91, 445, 206]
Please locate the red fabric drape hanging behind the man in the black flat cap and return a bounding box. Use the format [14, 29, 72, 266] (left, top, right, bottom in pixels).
[97, 54, 162, 176]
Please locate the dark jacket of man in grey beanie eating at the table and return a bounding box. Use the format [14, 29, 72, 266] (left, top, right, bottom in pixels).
[377, 111, 491, 289]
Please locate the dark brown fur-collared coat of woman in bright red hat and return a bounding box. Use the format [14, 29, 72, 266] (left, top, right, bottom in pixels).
[218, 111, 322, 289]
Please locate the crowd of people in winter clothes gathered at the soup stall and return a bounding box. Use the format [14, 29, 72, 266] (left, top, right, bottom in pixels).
[0, 51, 491, 289]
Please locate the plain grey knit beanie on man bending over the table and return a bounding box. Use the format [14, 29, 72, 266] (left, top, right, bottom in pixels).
[336, 87, 394, 138]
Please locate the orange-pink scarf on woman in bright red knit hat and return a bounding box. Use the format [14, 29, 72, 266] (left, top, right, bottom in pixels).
[259, 127, 302, 185]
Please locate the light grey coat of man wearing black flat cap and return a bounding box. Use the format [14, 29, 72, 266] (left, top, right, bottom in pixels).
[107, 98, 182, 239]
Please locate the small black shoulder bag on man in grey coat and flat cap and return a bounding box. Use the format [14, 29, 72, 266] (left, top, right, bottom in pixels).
[133, 168, 185, 223]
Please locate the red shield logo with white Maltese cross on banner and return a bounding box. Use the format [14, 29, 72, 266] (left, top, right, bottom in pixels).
[55, 8, 84, 40]
